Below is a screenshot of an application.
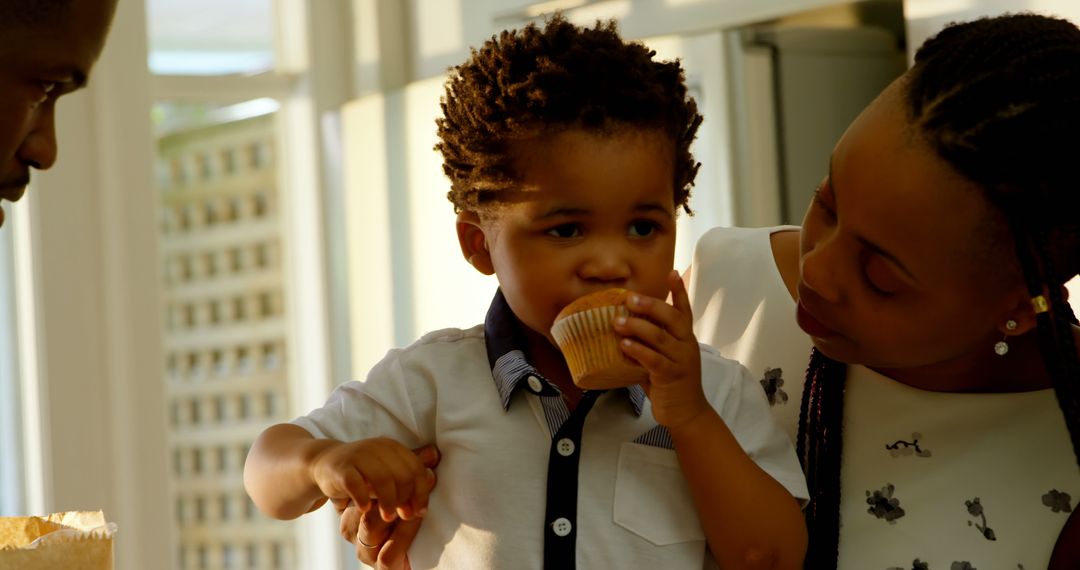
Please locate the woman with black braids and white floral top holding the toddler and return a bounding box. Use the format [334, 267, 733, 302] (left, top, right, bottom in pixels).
[342, 15, 1080, 570]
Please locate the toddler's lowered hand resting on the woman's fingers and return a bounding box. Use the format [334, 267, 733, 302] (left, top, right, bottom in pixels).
[310, 437, 435, 521]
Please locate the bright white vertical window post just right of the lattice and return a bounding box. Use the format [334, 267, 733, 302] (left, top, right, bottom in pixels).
[275, 0, 352, 570]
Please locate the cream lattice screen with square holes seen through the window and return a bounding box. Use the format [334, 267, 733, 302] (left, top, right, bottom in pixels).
[157, 113, 296, 570]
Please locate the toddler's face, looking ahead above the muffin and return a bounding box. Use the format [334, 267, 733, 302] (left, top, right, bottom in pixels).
[485, 128, 675, 340]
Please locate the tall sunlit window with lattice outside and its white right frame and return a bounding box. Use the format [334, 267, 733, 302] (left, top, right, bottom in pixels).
[147, 0, 350, 570]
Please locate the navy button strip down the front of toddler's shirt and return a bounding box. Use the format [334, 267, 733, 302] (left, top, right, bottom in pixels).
[543, 390, 604, 570]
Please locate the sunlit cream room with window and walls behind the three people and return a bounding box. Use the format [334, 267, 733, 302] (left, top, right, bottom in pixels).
[0, 0, 1080, 570]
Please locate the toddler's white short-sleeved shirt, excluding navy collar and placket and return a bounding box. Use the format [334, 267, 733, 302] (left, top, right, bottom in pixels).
[294, 291, 807, 570]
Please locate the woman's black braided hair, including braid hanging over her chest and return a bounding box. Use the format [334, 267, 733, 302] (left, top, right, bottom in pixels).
[797, 14, 1080, 569]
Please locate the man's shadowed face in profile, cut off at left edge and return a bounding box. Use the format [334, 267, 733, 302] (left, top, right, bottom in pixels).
[0, 0, 117, 225]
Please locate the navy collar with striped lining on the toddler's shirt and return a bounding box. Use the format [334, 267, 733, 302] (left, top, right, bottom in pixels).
[484, 289, 645, 416]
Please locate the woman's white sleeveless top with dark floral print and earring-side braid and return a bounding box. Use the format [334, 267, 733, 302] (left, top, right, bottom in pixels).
[689, 228, 1080, 570]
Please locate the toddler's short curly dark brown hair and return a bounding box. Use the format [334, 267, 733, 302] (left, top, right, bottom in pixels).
[435, 15, 702, 212]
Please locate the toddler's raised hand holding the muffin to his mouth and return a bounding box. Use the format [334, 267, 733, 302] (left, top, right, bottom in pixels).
[615, 271, 708, 430]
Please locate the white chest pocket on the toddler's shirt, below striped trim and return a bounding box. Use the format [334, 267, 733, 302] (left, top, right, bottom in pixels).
[613, 443, 705, 546]
